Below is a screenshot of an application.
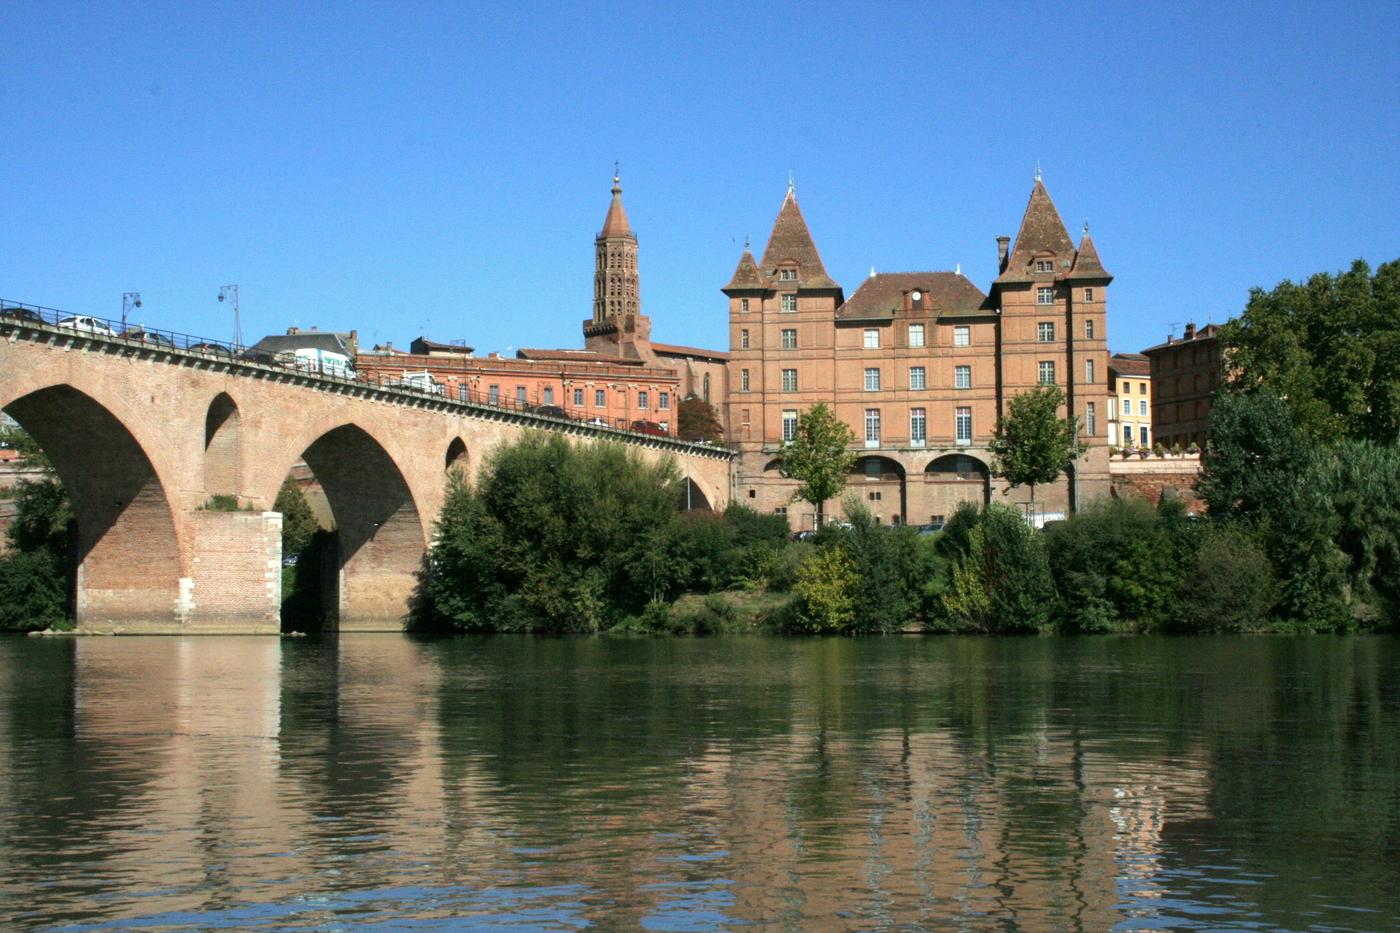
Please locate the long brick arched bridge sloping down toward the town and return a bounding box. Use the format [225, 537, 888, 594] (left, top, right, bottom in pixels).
[0, 318, 731, 633]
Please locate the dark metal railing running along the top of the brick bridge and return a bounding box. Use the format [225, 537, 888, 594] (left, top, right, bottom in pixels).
[0, 298, 729, 451]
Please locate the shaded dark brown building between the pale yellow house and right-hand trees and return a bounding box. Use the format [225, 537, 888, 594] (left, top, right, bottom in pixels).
[1142, 324, 1225, 450]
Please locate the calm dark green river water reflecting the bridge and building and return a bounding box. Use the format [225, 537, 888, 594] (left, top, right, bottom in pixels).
[0, 636, 1400, 930]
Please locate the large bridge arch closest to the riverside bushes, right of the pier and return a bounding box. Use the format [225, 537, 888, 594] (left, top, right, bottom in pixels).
[265, 423, 428, 629]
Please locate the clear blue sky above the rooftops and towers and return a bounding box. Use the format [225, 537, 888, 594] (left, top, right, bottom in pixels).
[0, 0, 1400, 352]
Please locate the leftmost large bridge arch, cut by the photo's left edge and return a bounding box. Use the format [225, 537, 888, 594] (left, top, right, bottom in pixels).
[3, 384, 186, 626]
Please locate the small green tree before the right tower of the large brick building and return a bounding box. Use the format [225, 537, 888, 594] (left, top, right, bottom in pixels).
[990, 385, 1085, 502]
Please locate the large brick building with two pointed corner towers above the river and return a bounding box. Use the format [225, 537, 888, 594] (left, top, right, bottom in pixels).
[722, 178, 1112, 527]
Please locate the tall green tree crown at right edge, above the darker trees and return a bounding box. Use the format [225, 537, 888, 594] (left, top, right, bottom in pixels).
[1221, 259, 1400, 444]
